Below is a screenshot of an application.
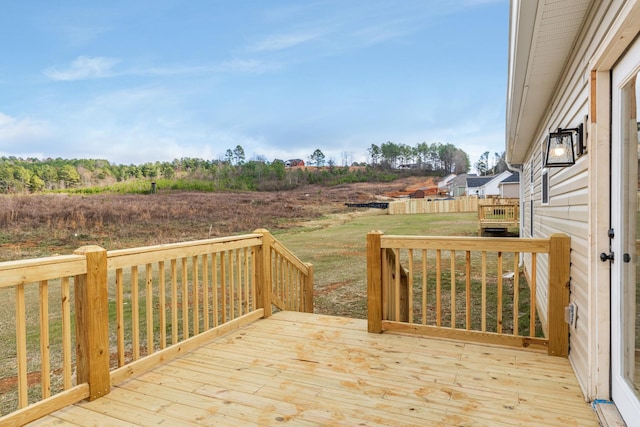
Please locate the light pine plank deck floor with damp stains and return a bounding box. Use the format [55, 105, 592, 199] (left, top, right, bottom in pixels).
[31, 312, 598, 426]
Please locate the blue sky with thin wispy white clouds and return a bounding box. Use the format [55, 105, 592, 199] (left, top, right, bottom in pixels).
[0, 0, 509, 165]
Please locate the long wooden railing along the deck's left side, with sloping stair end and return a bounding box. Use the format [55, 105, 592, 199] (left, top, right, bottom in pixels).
[0, 230, 313, 425]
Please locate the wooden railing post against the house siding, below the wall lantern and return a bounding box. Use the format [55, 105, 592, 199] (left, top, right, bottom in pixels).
[547, 233, 571, 357]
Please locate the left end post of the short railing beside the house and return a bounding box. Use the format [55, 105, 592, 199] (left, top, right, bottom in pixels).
[367, 231, 384, 334]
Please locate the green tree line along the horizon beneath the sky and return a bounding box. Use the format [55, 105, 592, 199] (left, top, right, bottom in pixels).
[0, 142, 480, 193]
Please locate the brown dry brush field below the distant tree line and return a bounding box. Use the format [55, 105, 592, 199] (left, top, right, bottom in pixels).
[0, 178, 433, 261]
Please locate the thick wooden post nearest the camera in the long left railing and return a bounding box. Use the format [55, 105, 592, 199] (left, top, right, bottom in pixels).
[74, 246, 111, 400]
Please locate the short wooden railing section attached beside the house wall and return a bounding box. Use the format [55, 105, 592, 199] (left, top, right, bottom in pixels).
[367, 232, 570, 356]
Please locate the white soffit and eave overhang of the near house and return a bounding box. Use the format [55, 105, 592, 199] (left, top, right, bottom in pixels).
[506, 0, 592, 164]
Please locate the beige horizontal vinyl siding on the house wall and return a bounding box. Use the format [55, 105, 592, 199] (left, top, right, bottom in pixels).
[521, 1, 627, 399]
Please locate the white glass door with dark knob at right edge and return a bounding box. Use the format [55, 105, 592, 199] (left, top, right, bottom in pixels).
[611, 35, 640, 425]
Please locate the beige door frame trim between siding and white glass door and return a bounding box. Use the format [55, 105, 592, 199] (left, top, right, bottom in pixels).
[588, 0, 640, 408]
